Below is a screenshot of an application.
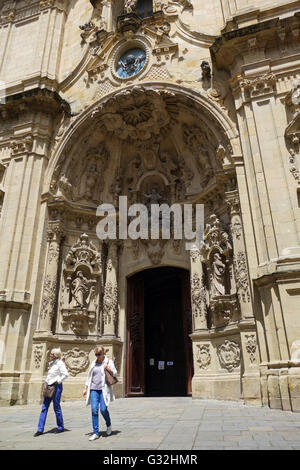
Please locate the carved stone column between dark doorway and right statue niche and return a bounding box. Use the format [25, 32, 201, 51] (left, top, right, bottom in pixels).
[190, 246, 207, 332]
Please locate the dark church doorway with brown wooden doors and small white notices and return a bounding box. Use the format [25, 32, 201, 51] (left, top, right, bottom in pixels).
[126, 267, 193, 396]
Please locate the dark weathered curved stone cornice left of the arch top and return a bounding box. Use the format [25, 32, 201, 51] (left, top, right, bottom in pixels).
[0, 88, 71, 119]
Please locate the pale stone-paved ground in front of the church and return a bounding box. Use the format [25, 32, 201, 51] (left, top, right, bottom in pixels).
[0, 397, 300, 450]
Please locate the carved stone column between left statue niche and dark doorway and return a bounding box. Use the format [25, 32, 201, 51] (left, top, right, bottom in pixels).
[103, 241, 119, 336]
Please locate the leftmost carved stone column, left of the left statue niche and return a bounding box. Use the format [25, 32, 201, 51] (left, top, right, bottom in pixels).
[38, 223, 63, 333]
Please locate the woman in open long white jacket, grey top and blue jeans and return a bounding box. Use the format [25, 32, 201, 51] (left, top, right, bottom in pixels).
[83, 346, 117, 441]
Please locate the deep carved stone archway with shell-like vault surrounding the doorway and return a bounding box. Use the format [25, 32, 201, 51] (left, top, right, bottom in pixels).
[31, 85, 256, 404]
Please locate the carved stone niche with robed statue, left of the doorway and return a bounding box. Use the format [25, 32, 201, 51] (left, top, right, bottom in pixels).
[58, 233, 102, 336]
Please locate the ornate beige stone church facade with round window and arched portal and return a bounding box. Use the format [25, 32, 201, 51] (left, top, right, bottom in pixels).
[0, 0, 300, 411]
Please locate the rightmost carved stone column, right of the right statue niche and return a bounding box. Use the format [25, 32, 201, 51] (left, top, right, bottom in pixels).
[226, 190, 254, 319]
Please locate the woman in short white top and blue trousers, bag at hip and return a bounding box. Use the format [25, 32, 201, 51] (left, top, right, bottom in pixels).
[34, 348, 69, 437]
